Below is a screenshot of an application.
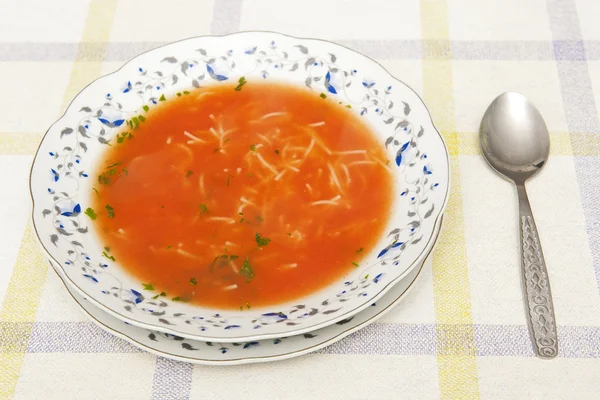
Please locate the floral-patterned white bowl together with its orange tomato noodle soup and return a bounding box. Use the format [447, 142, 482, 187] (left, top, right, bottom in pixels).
[30, 32, 449, 341]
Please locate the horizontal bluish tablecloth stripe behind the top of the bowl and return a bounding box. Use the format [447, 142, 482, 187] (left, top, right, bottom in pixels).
[5, 40, 600, 62]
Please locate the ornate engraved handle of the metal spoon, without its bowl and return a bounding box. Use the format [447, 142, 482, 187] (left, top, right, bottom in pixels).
[517, 184, 558, 359]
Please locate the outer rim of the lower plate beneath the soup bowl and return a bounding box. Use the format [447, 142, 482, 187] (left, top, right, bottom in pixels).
[48, 218, 443, 367]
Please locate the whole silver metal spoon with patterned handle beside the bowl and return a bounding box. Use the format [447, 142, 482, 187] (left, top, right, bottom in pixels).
[479, 92, 558, 359]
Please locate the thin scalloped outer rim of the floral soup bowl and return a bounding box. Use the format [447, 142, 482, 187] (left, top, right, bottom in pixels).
[28, 30, 451, 343]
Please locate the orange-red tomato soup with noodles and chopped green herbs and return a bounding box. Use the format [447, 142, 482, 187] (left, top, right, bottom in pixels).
[86, 82, 393, 310]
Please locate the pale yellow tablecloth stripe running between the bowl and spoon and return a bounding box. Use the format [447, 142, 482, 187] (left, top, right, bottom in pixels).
[421, 0, 479, 399]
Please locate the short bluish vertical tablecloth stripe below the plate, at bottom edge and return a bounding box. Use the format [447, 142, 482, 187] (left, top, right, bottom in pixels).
[150, 357, 194, 400]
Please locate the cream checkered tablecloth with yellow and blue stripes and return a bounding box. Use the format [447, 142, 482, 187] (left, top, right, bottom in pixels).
[0, 0, 600, 400]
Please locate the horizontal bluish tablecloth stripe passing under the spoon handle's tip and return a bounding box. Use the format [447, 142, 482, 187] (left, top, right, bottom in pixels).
[12, 322, 600, 360]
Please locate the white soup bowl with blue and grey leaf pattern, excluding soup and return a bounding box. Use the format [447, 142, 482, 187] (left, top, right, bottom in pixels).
[30, 32, 449, 342]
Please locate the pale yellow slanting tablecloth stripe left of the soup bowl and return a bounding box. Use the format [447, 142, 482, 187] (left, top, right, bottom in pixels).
[0, 0, 117, 399]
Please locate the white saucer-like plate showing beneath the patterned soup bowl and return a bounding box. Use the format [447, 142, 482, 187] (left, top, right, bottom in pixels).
[50, 222, 442, 365]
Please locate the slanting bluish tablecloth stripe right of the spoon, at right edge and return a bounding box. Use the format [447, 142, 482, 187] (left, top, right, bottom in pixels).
[547, 0, 600, 290]
